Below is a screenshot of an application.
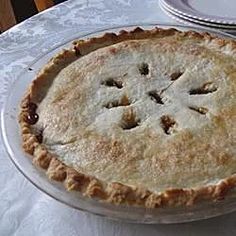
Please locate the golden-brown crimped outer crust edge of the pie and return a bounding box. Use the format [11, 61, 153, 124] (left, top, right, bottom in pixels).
[19, 28, 236, 208]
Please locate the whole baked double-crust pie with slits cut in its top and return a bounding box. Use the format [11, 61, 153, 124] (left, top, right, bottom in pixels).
[19, 28, 236, 208]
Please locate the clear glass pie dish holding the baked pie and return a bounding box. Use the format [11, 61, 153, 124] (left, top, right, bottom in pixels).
[1, 23, 236, 223]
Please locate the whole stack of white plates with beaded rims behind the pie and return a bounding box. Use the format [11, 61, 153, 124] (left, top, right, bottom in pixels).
[159, 0, 236, 33]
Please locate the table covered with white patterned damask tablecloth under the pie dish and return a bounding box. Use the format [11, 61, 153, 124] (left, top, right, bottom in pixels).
[0, 0, 236, 236]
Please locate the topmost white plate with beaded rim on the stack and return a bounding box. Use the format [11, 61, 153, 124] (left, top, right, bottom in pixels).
[163, 0, 236, 25]
